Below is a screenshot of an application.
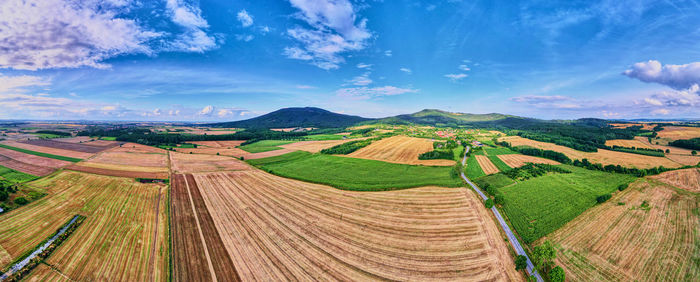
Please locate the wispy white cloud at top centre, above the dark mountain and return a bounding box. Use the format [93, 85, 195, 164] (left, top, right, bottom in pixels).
[283, 0, 371, 70]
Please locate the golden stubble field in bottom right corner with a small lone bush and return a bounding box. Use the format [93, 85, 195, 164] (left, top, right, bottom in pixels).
[548, 179, 700, 281]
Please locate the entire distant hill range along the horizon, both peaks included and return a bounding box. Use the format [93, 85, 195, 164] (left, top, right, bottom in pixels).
[210, 107, 608, 128]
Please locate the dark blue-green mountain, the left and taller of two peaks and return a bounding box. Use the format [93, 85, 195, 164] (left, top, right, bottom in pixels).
[210, 107, 371, 128]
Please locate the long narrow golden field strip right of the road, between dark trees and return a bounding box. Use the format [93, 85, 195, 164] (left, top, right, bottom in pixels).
[498, 136, 682, 168]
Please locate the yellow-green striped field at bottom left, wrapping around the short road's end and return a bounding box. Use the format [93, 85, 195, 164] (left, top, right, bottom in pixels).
[0, 171, 169, 281]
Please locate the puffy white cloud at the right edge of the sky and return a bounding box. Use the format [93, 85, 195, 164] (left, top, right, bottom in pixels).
[623, 60, 700, 90]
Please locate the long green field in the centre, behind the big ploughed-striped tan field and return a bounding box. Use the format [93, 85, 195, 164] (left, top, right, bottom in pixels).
[247, 151, 462, 191]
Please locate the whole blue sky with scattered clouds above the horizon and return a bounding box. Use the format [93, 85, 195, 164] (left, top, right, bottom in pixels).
[0, 0, 700, 121]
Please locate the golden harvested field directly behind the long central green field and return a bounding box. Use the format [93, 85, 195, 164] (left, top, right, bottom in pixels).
[343, 135, 455, 166]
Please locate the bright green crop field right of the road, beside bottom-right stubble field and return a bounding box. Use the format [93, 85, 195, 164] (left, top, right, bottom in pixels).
[499, 165, 635, 244]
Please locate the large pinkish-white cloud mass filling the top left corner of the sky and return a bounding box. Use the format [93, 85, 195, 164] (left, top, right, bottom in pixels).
[0, 0, 216, 70]
